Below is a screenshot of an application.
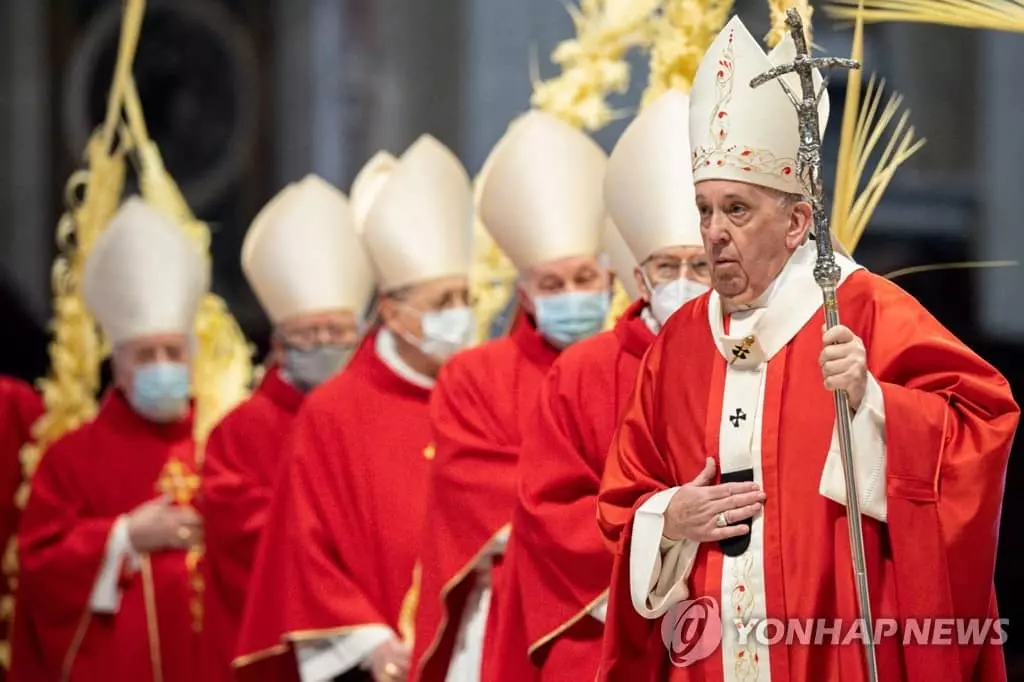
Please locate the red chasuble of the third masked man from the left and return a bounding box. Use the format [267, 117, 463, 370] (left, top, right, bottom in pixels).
[234, 327, 433, 681]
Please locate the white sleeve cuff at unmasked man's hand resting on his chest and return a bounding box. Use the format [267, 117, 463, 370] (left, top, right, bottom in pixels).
[630, 487, 700, 620]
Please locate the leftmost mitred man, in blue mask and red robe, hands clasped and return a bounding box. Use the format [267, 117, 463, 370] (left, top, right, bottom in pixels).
[10, 198, 210, 682]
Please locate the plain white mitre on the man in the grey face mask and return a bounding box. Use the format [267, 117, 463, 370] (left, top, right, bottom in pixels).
[242, 175, 374, 325]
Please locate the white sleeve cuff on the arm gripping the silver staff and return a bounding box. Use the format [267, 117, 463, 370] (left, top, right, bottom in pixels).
[818, 374, 887, 523]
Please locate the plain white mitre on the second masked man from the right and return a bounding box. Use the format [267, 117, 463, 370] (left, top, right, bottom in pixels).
[478, 111, 607, 272]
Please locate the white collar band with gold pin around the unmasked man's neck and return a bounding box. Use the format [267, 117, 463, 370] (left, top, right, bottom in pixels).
[708, 240, 863, 368]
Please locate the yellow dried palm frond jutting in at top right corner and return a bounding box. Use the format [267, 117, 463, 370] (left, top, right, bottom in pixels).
[825, 0, 1024, 33]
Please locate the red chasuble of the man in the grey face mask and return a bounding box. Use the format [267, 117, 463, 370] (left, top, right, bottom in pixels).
[200, 368, 303, 682]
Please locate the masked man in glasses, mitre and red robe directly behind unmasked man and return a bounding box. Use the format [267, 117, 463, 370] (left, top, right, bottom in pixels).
[510, 90, 710, 681]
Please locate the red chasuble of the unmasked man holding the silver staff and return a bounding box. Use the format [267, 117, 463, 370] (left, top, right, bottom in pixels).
[599, 267, 1019, 682]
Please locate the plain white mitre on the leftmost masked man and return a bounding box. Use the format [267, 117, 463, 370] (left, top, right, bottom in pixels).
[82, 197, 210, 346]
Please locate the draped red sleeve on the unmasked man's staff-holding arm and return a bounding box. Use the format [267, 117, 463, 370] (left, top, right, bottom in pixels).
[865, 274, 1020, 679]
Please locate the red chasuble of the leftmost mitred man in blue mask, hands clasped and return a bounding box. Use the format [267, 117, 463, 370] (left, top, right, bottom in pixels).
[9, 390, 201, 682]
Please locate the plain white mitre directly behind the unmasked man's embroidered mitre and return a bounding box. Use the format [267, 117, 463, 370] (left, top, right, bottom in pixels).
[604, 90, 703, 263]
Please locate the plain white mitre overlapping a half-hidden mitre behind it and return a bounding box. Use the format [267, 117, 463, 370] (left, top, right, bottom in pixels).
[362, 135, 473, 292]
